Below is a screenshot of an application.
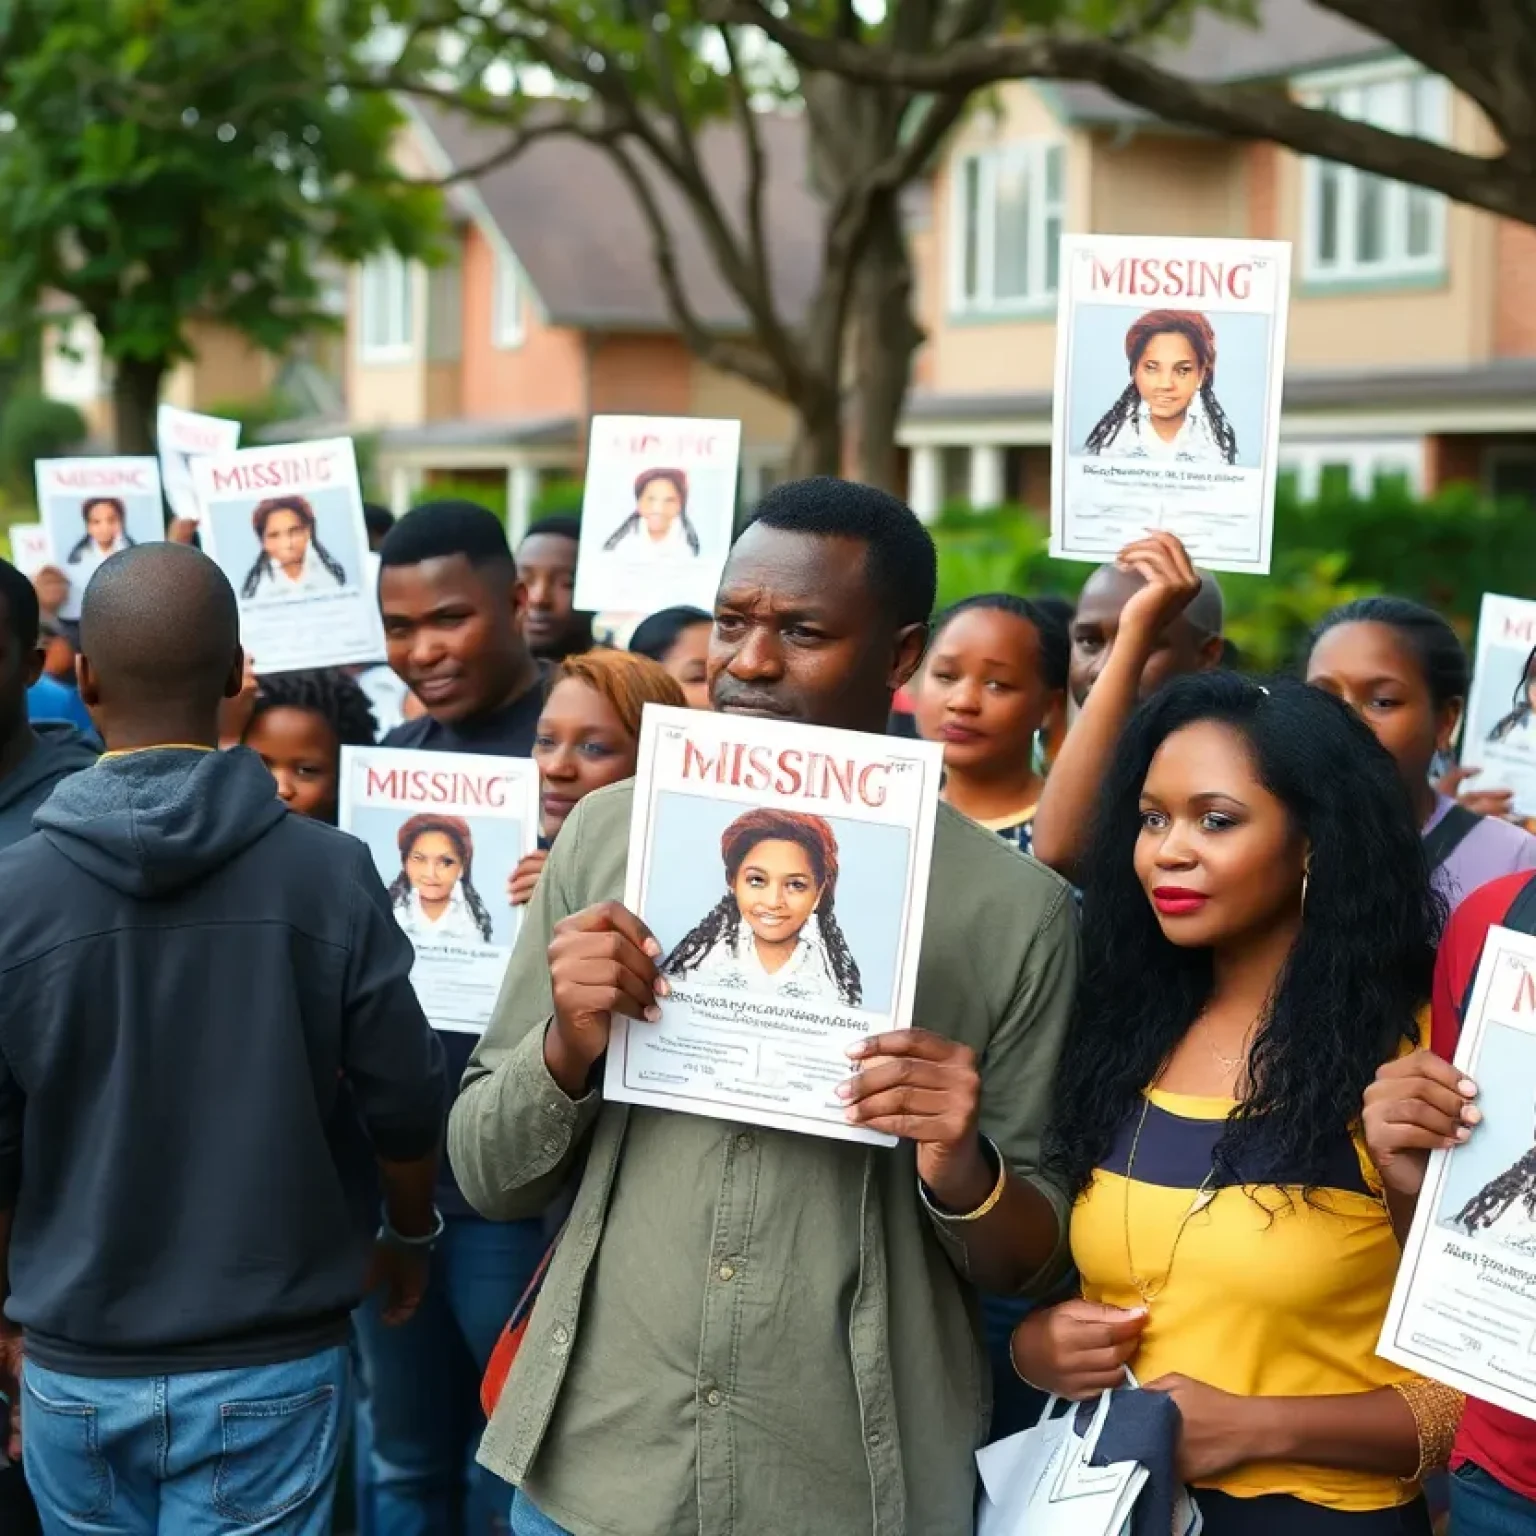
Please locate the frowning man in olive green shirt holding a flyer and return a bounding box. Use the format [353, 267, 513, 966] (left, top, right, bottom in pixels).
[449, 479, 1077, 1536]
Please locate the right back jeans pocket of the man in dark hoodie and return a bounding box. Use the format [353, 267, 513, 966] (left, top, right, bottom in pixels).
[214, 1385, 336, 1525]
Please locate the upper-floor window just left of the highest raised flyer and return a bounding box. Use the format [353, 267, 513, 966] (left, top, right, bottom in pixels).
[951, 140, 1064, 313]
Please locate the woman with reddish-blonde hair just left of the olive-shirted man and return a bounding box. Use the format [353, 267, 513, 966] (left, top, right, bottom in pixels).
[508, 651, 687, 906]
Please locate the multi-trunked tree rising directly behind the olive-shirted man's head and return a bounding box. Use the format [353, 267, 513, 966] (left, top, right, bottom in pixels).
[364, 0, 988, 485]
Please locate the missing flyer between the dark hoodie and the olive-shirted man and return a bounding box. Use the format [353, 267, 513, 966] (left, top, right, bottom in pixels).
[338, 746, 539, 1035]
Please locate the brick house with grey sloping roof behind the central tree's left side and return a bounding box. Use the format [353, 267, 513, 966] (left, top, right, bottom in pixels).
[340, 104, 820, 535]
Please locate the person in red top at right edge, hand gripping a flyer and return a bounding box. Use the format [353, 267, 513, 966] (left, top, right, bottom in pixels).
[1362, 871, 1536, 1536]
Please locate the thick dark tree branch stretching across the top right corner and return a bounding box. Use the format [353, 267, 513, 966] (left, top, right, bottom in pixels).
[703, 0, 1536, 224]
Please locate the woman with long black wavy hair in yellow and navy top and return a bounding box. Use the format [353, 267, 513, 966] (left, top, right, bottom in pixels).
[1014, 673, 1459, 1536]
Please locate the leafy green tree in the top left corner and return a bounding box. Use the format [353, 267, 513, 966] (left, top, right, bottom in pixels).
[0, 0, 439, 453]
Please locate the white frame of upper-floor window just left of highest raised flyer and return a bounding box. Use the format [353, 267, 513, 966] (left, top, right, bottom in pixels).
[949, 138, 1066, 315]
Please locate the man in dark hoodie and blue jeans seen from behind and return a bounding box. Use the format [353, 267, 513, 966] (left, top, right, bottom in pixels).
[0, 544, 444, 1536]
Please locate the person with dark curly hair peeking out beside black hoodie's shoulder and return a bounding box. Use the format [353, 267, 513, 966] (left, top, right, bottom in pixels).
[243, 670, 378, 825]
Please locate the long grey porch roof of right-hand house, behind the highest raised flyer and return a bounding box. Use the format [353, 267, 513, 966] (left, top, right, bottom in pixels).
[905, 358, 1536, 422]
